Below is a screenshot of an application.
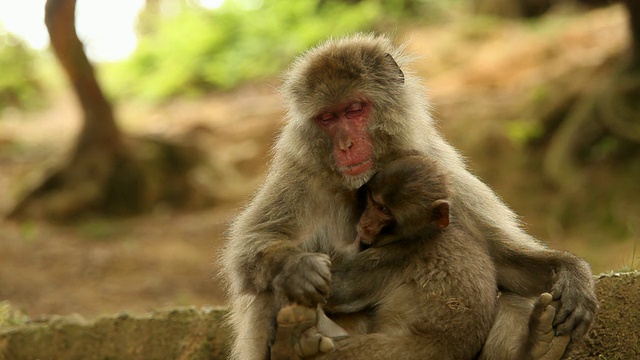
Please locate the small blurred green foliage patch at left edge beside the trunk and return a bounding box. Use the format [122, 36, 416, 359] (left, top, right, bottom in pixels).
[0, 28, 44, 112]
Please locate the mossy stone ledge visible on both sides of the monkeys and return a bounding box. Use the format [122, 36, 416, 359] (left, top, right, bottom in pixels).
[0, 271, 640, 360]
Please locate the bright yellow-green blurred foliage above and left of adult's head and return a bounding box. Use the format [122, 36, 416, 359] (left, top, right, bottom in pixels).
[104, 0, 432, 101]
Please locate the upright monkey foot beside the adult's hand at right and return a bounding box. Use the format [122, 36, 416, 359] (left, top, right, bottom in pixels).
[529, 293, 571, 360]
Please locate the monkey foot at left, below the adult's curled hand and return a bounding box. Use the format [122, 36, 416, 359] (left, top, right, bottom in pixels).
[271, 304, 335, 360]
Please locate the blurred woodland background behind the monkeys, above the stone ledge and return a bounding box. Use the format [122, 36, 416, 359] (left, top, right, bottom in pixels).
[0, 0, 640, 320]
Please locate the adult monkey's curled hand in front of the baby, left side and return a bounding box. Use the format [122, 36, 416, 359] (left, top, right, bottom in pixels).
[273, 253, 331, 307]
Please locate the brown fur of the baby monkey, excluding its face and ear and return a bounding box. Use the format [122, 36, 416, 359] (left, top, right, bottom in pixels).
[322, 156, 498, 359]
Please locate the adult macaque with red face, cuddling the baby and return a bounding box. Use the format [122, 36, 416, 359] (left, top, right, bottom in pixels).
[221, 35, 597, 360]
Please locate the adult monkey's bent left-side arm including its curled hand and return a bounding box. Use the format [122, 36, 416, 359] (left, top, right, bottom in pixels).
[222, 176, 331, 306]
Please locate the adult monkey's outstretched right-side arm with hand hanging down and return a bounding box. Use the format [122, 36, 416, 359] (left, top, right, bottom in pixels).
[436, 162, 598, 340]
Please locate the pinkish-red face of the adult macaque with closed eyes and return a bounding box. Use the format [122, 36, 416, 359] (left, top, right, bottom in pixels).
[315, 99, 374, 176]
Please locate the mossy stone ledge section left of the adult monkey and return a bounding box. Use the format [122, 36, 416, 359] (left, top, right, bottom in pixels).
[0, 308, 229, 360]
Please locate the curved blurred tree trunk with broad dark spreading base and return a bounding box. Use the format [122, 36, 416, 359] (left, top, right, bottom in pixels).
[9, 0, 215, 219]
